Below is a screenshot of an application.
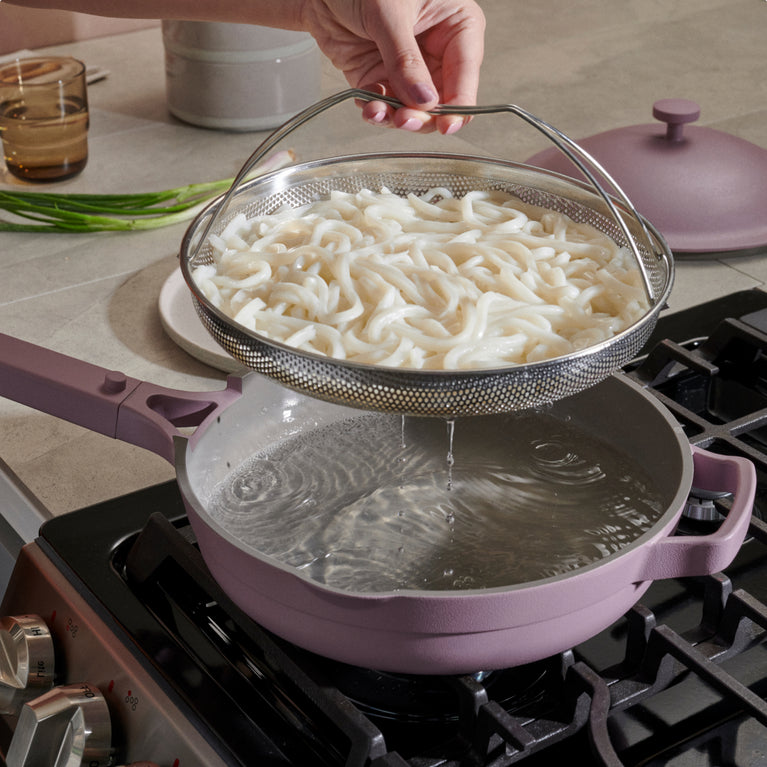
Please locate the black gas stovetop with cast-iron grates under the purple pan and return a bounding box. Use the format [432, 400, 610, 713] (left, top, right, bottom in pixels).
[34, 291, 767, 767]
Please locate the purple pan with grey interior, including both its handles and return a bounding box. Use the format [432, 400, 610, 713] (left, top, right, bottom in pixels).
[0, 335, 756, 674]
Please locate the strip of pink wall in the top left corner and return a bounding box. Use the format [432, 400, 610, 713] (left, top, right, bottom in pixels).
[0, 2, 160, 55]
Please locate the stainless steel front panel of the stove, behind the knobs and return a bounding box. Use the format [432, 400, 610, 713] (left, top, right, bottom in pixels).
[0, 540, 227, 767]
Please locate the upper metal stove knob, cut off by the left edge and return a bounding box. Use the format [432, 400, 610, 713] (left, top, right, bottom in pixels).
[0, 615, 54, 715]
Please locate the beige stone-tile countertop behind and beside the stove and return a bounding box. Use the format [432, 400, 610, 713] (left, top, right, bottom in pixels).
[0, 0, 767, 514]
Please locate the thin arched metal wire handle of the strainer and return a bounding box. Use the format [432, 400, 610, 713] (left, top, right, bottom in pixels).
[201, 88, 661, 304]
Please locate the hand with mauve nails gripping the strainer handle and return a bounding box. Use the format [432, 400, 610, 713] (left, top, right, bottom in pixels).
[302, 0, 485, 133]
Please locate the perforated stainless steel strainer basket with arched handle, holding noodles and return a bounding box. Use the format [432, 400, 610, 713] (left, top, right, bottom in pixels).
[180, 89, 673, 417]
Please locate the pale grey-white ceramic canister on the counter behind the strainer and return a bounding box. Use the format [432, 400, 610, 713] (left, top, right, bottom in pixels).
[162, 21, 321, 131]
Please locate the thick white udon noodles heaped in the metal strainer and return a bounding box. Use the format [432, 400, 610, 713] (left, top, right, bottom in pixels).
[193, 189, 648, 370]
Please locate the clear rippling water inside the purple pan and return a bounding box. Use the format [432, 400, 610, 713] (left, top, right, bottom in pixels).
[209, 412, 664, 592]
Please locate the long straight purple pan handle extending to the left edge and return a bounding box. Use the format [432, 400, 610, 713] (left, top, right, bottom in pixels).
[0, 334, 242, 463]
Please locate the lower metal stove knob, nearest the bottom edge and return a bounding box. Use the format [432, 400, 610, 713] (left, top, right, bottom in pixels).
[5, 684, 114, 767]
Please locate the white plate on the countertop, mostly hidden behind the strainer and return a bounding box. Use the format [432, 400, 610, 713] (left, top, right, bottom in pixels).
[159, 269, 244, 373]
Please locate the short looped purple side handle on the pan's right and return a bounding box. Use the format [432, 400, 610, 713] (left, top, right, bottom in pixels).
[639, 447, 756, 581]
